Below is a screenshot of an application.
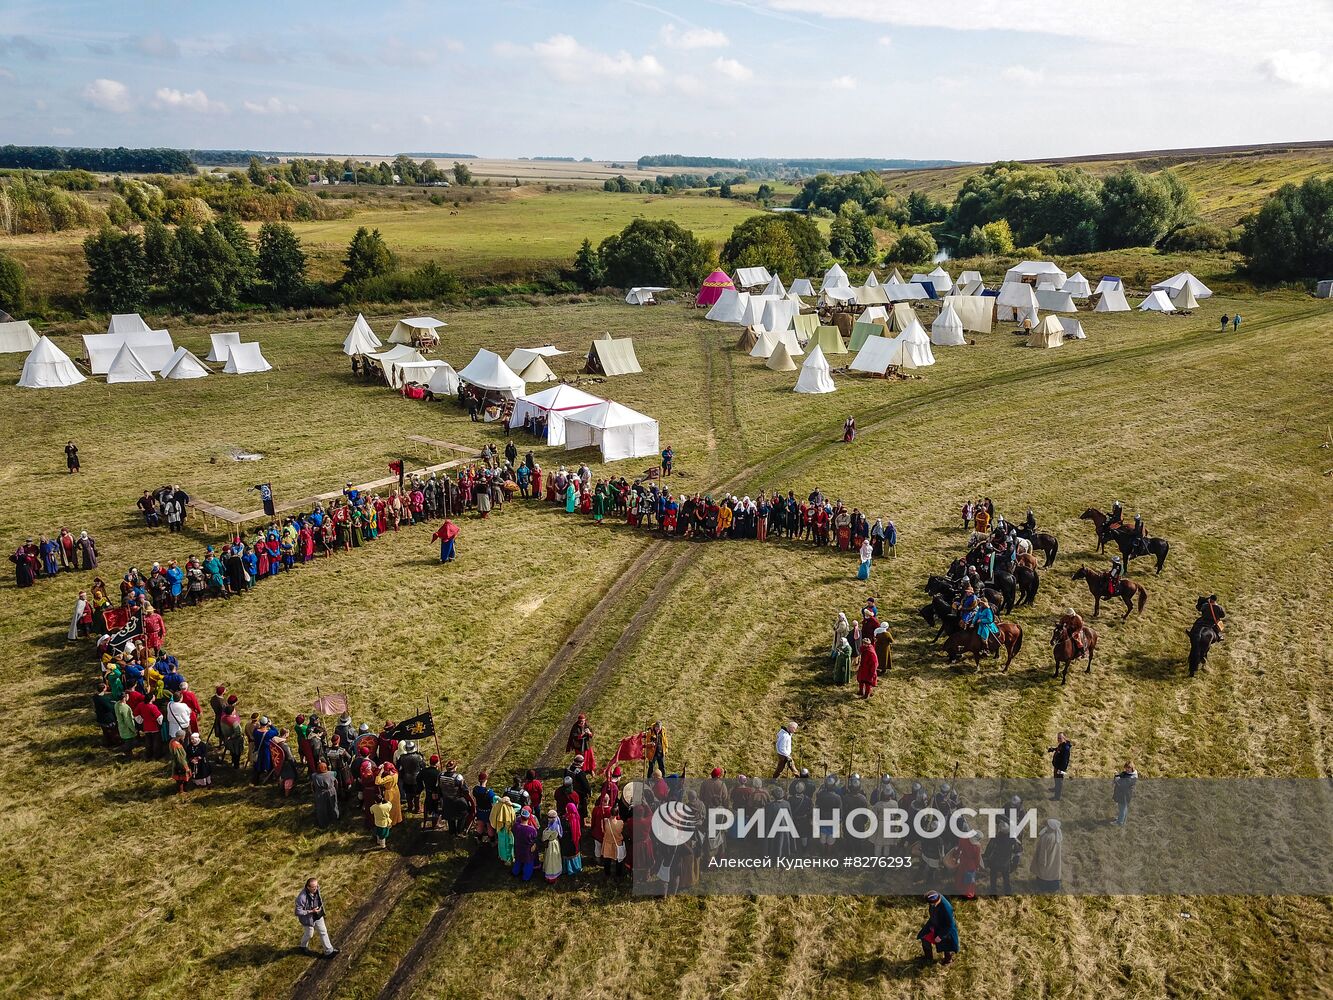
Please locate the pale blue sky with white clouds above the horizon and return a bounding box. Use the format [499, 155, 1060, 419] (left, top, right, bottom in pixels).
[0, 0, 1333, 160]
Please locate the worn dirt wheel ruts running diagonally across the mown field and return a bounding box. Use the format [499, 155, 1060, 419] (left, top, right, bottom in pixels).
[293, 309, 1318, 1000]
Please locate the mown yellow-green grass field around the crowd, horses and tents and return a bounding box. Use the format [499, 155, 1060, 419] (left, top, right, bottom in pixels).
[0, 254, 1333, 1000]
